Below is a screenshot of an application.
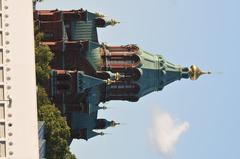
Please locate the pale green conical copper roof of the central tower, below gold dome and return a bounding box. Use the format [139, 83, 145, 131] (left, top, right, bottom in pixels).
[136, 50, 188, 97]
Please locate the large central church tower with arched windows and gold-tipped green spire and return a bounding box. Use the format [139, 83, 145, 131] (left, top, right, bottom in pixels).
[94, 44, 209, 102]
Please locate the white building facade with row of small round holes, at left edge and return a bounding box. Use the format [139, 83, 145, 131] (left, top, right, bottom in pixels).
[0, 0, 39, 159]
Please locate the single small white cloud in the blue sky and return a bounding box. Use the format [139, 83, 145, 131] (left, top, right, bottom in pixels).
[150, 109, 189, 156]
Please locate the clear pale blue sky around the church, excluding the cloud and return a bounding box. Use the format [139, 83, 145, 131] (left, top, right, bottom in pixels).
[38, 0, 240, 159]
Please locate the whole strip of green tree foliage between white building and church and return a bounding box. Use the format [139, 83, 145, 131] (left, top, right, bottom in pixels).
[35, 26, 76, 159]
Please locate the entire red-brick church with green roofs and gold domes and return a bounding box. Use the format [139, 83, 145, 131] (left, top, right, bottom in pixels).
[34, 9, 209, 141]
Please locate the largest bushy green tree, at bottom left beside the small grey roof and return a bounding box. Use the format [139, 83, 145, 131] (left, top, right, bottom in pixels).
[38, 105, 75, 159]
